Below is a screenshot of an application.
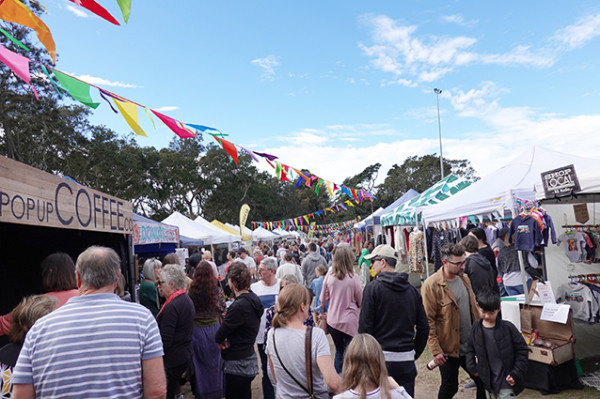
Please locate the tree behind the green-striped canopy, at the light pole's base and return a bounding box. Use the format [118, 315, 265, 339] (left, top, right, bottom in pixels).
[375, 154, 479, 208]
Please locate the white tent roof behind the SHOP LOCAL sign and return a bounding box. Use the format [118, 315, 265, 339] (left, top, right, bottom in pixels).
[423, 146, 597, 222]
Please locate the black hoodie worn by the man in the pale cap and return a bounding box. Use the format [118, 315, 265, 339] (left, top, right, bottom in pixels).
[358, 272, 429, 359]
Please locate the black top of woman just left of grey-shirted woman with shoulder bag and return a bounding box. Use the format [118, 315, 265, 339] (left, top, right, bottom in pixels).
[215, 291, 264, 360]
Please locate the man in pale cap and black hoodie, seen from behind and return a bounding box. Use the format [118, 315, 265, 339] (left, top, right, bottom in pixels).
[358, 244, 429, 397]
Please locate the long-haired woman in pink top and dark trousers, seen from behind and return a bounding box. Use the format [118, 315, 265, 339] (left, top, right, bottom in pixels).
[321, 244, 362, 373]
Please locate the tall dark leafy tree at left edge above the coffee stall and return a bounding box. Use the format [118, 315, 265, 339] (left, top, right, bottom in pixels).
[0, 11, 89, 172]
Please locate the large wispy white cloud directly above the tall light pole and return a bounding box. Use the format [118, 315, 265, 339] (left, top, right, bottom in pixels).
[358, 15, 555, 83]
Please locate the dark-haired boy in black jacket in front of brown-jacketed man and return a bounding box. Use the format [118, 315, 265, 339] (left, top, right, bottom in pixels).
[466, 288, 529, 399]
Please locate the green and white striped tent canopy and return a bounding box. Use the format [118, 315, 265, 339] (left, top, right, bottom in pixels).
[381, 175, 471, 226]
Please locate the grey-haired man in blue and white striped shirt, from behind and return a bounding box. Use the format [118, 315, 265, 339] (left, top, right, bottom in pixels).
[12, 246, 166, 399]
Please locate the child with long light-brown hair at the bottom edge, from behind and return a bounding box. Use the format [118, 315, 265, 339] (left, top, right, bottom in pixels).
[333, 334, 412, 399]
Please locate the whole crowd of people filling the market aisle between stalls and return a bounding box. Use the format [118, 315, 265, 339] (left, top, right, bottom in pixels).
[0, 231, 527, 399]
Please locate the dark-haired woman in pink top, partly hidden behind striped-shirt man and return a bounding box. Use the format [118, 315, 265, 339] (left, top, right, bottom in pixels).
[0, 252, 79, 335]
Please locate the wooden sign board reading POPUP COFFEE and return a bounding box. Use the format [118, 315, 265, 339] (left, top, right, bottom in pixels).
[0, 157, 133, 234]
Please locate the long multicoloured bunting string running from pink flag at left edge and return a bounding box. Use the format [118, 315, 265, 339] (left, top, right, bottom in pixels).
[0, 40, 374, 203]
